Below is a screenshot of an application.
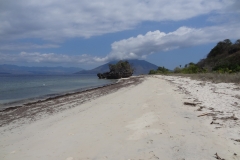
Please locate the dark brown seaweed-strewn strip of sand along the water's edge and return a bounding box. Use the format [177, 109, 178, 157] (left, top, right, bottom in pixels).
[0, 76, 143, 127]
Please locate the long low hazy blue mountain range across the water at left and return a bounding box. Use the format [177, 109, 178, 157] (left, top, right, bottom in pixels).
[0, 64, 83, 75]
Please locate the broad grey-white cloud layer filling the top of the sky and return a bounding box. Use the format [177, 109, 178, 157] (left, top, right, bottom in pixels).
[0, 0, 239, 41]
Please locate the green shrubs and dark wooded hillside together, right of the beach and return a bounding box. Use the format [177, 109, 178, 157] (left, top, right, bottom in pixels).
[149, 39, 240, 77]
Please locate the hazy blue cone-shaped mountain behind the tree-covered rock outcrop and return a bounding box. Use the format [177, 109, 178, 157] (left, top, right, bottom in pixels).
[76, 59, 158, 75]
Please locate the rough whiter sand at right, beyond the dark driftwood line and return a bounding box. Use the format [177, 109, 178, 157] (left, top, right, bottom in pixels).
[162, 76, 240, 139]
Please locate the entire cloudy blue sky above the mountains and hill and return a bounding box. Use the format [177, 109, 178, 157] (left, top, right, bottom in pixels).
[0, 0, 240, 69]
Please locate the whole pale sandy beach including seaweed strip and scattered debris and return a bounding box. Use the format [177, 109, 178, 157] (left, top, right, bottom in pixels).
[0, 75, 240, 160]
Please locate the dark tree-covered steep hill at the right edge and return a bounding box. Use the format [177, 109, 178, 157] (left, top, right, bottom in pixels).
[197, 39, 240, 73]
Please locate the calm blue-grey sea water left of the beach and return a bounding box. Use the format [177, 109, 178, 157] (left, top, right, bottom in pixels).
[0, 75, 116, 110]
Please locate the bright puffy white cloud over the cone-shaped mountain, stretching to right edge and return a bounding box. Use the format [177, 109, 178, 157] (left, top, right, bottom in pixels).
[98, 24, 240, 61]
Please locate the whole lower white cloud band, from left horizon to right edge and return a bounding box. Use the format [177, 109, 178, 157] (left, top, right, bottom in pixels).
[0, 23, 240, 66]
